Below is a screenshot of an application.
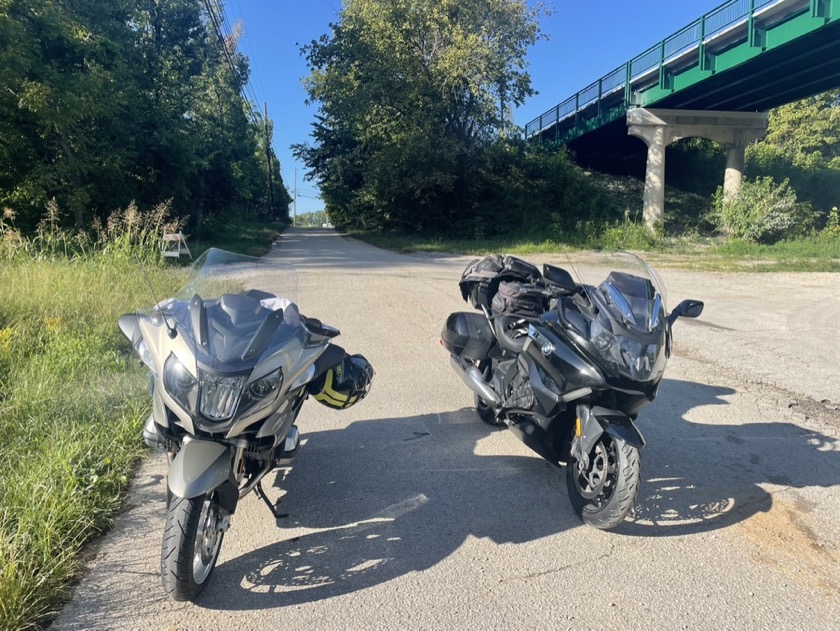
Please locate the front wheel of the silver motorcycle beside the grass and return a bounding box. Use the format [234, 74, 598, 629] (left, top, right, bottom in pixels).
[160, 492, 225, 601]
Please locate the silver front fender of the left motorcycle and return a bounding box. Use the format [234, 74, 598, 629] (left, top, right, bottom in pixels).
[169, 440, 233, 499]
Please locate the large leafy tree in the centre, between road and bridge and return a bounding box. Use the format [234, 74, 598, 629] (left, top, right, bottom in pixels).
[296, 0, 544, 231]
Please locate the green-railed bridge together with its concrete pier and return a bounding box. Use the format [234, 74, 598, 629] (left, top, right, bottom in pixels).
[525, 0, 840, 225]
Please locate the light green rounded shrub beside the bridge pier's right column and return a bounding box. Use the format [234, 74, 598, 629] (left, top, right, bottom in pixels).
[711, 177, 814, 243]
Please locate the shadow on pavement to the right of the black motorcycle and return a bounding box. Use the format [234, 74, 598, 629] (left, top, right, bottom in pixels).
[614, 379, 840, 537]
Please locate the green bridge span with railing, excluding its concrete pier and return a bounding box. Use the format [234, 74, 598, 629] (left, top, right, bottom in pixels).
[525, 0, 840, 142]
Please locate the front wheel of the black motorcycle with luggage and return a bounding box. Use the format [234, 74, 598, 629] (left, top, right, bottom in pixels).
[566, 432, 642, 530]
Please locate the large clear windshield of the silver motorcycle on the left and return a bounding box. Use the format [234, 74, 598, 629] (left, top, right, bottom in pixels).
[140, 248, 301, 372]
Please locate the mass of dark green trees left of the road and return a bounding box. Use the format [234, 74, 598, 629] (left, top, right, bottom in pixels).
[0, 0, 291, 228]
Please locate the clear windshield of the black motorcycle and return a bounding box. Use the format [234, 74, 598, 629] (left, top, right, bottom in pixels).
[569, 252, 667, 331]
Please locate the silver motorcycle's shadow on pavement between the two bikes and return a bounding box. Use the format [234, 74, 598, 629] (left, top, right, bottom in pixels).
[199, 409, 581, 610]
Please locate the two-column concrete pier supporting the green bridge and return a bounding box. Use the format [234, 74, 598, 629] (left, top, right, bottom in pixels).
[627, 108, 767, 231]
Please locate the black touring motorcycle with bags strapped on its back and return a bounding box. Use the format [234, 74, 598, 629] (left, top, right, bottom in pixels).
[441, 252, 703, 529]
